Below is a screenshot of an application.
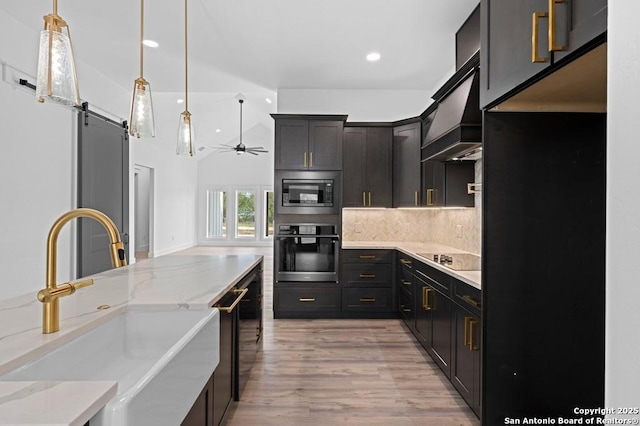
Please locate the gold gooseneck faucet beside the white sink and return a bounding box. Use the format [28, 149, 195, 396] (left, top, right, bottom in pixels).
[38, 208, 127, 334]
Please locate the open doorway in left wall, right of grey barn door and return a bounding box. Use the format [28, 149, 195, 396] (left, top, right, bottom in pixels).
[133, 164, 153, 262]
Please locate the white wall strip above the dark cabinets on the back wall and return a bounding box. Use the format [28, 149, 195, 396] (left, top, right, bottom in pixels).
[278, 89, 433, 121]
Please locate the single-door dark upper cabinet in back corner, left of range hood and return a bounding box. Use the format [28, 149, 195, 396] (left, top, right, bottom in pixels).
[393, 119, 422, 207]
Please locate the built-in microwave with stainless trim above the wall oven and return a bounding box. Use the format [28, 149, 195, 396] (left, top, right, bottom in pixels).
[275, 171, 341, 214]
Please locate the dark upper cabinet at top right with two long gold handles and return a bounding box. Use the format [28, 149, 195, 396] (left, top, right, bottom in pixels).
[480, 0, 607, 108]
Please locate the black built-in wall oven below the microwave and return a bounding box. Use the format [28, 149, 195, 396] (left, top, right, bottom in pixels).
[274, 223, 340, 282]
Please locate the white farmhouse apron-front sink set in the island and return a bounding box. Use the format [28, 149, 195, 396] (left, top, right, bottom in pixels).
[0, 305, 220, 426]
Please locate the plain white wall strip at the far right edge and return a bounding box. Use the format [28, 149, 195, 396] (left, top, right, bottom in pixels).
[605, 0, 640, 412]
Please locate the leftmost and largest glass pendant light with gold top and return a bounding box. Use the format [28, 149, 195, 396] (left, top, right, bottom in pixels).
[36, 0, 80, 105]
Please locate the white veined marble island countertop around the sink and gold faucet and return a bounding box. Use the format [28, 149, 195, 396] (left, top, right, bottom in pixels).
[0, 255, 263, 424]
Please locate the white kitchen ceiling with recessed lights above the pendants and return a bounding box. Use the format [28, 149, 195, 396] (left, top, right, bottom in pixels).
[0, 0, 478, 92]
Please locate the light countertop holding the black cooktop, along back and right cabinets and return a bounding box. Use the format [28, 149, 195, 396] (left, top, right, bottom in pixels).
[342, 241, 482, 290]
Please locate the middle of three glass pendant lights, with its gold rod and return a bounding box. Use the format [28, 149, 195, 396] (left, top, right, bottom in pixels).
[129, 0, 156, 138]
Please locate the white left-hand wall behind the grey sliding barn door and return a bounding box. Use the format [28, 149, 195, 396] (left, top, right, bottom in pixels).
[0, 11, 197, 299]
